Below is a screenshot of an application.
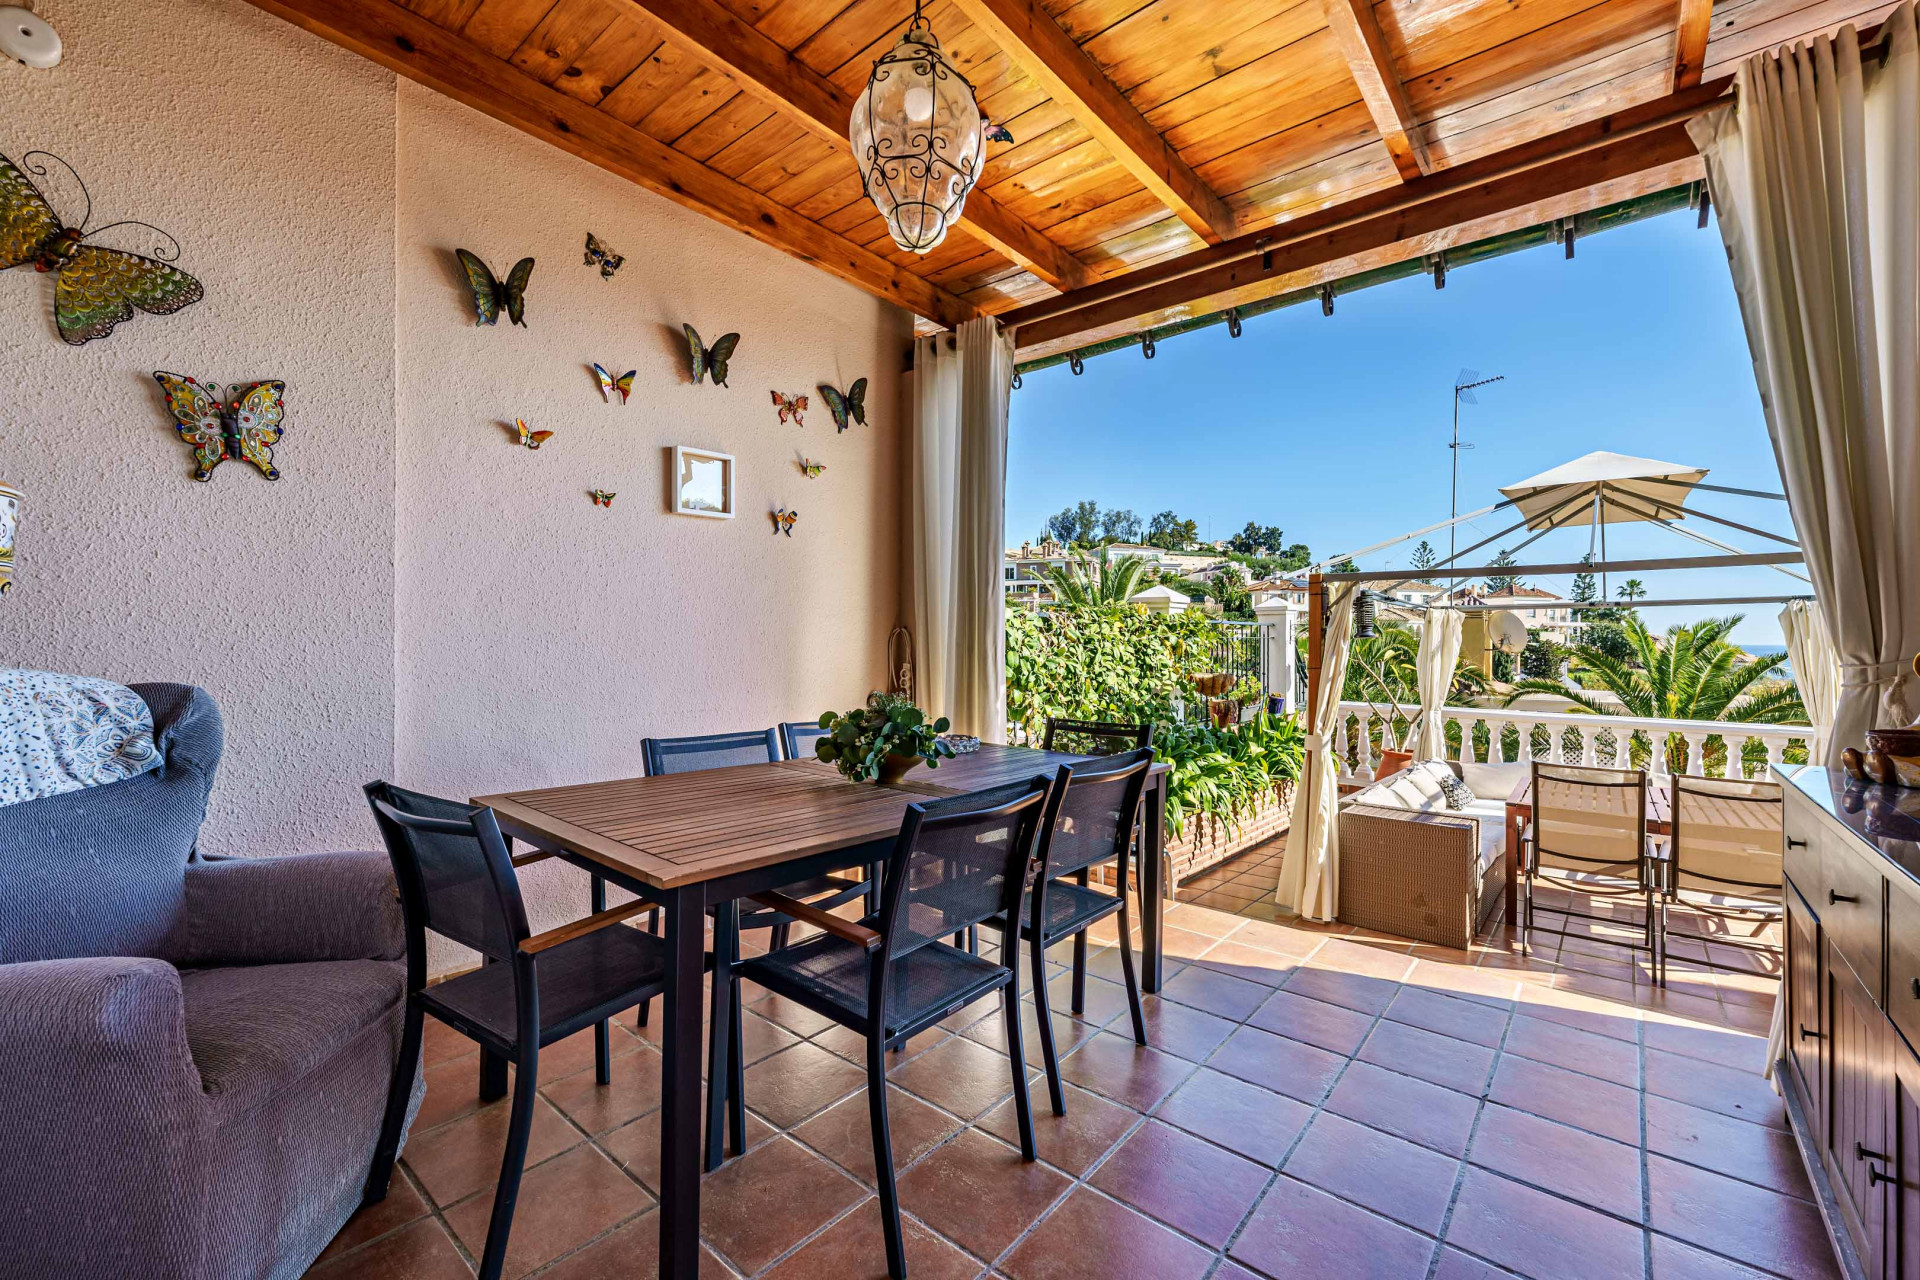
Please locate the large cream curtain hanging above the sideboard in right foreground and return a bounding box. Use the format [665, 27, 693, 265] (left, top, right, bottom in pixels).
[1688, 2, 1920, 768]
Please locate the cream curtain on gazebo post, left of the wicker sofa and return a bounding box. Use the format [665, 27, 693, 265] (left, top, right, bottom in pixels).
[1273, 581, 1354, 921]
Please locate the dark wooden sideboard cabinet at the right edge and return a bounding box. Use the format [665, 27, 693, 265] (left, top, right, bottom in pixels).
[1780, 766, 1920, 1280]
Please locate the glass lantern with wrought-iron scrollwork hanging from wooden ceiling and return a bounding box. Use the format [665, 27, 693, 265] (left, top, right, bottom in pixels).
[849, 0, 987, 253]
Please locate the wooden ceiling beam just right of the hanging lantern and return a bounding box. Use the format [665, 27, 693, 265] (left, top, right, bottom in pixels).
[954, 0, 1236, 244]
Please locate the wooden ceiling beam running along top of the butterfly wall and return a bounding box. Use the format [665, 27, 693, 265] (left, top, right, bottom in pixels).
[252, 0, 983, 326]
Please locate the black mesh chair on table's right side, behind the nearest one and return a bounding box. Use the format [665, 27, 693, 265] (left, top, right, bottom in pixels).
[981, 747, 1154, 1115]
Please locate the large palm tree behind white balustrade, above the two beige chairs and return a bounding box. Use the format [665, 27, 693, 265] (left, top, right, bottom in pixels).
[1505, 614, 1807, 773]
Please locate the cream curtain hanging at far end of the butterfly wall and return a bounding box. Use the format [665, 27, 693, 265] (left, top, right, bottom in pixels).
[906, 319, 1014, 743]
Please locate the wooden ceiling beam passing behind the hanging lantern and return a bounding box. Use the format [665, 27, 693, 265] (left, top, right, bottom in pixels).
[624, 0, 1098, 290]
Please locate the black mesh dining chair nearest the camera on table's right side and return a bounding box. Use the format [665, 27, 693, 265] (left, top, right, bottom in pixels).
[708, 777, 1048, 1280]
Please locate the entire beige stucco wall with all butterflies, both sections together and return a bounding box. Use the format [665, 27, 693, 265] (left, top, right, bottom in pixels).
[0, 0, 910, 959]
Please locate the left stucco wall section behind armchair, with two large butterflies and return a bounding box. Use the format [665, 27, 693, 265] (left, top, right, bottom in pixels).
[0, 0, 396, 854]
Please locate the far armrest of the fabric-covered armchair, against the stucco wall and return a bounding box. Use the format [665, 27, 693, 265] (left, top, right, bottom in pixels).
[184, 850, 407, 965]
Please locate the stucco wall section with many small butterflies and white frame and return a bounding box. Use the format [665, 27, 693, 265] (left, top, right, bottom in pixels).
[396, 83, 910, 951]
